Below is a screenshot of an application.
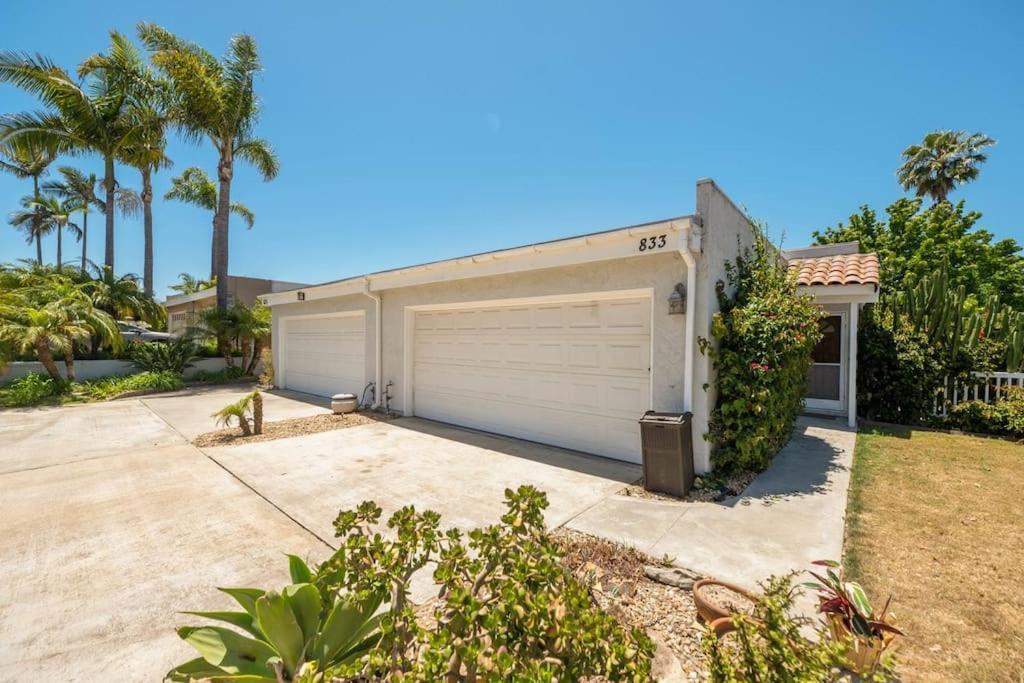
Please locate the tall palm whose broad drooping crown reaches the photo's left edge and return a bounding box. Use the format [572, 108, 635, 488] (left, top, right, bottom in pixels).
[0, 51, 144, 270]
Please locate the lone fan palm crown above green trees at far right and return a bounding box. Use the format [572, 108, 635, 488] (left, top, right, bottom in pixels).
[896, 130, 995, 204]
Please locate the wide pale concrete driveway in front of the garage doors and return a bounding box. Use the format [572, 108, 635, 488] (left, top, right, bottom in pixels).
[0, 387, 639, 681]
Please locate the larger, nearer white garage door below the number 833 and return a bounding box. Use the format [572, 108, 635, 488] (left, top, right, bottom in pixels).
[413, 298, 650, 463]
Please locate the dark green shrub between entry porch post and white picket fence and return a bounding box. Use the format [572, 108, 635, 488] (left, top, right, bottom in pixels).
[857, 313, 948, 424]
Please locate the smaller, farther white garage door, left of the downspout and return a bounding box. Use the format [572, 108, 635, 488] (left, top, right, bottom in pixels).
[282, 312, 367, 396]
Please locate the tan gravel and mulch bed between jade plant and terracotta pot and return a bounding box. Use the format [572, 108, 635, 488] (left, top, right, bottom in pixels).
[554, 528, 708, 681]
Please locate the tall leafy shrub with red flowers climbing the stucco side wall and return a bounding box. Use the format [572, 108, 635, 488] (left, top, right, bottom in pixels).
[698, 226, 821, 472]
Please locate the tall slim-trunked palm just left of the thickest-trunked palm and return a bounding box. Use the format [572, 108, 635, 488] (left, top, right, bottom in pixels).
[78, 31, 171, 296]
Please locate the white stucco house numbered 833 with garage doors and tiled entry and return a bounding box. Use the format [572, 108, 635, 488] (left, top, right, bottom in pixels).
[262, 180, 878, 472]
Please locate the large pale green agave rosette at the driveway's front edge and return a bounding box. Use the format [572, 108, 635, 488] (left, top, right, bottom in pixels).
[166, 555, 384, 683]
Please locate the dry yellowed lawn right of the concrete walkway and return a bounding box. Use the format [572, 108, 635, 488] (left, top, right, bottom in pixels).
[846, 429, 1024, 682]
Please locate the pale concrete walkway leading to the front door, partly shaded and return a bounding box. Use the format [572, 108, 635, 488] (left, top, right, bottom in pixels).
[567, 418, 856, 589]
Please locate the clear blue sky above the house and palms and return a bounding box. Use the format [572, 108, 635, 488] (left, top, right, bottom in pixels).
[0, 0, 1024, 294]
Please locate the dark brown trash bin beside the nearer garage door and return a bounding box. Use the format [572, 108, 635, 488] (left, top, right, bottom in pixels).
[640, 411, 693, 498]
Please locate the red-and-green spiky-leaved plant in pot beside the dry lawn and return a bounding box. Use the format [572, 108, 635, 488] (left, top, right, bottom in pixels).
[801, 560, 903, 673]
